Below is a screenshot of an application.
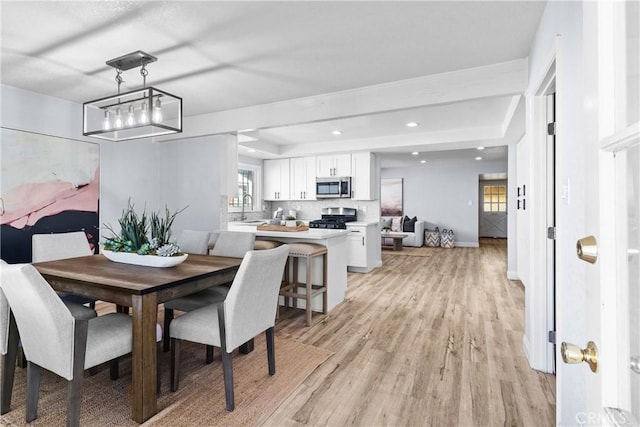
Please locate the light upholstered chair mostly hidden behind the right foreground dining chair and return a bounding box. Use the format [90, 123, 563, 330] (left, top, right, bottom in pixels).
[163, 231, 256, 363]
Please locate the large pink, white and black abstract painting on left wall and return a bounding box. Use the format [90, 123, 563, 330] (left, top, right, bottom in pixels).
[0, 128, 100, 263]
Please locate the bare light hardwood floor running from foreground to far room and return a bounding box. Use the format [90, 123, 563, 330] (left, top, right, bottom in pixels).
[266, 239, 555, 426]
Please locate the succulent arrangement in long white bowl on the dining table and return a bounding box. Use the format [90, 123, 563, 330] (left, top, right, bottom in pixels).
[102, 200, 187, 267]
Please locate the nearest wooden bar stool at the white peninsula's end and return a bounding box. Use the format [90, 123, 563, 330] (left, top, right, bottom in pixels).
[280, 242, 327, 326]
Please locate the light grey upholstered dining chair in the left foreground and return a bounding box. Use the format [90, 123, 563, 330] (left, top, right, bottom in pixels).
[0, 264, 132, 426]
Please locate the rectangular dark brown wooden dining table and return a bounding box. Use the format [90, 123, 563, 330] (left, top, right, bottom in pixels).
[28, 254, 242, 423]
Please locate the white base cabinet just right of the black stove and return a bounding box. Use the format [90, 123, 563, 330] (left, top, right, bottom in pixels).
[347, 223, 380, 273]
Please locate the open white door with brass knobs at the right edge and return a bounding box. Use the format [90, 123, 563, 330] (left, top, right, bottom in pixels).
[576, 1, 640, 425]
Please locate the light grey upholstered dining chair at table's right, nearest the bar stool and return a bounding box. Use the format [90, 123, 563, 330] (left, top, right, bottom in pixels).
[170, 245, 289, 411]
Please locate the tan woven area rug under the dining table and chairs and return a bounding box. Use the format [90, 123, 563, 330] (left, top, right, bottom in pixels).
[0, 336, 331, 427]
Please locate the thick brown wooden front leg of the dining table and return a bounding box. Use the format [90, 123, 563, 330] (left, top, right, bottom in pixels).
[131, 293, 158, 423]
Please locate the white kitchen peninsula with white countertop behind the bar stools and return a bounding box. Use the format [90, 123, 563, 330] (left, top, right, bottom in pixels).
[228, 226, 348, 312]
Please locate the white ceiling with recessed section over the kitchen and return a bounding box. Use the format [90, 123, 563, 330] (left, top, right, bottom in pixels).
[0, 1, 545, 166]
